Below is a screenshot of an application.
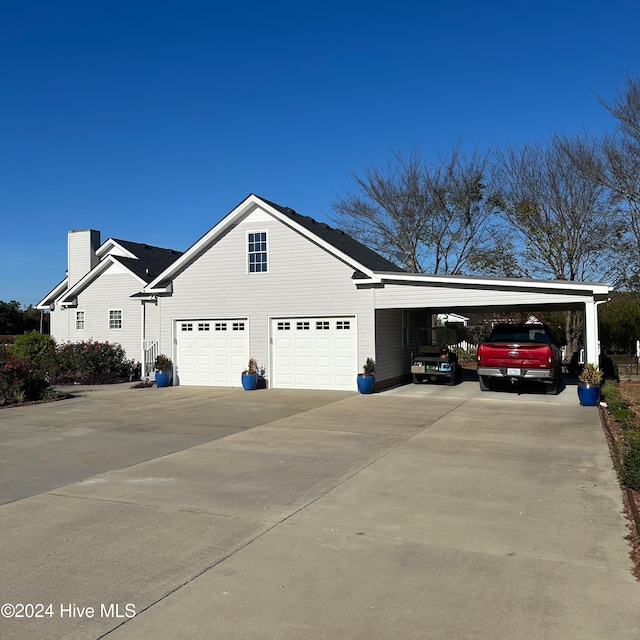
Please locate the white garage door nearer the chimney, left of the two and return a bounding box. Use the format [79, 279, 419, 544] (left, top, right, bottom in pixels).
[176, 319, 249, 387]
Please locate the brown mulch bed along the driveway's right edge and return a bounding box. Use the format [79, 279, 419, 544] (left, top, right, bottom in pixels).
[599, 382, 640, 582]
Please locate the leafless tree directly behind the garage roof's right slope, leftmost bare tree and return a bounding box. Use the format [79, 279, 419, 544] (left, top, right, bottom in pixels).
[332, 145, 502, 274]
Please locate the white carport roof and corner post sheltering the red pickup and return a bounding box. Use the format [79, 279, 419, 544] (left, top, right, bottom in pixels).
[369, 273, 611, 364]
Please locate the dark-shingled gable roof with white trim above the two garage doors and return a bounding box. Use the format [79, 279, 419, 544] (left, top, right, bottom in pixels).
[145, 193, 405, 293]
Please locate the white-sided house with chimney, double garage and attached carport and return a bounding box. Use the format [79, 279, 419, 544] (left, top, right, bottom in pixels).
[38, 194, 609, 390]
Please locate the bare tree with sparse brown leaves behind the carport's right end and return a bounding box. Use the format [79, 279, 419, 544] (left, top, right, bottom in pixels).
[497, 138, 616, 352]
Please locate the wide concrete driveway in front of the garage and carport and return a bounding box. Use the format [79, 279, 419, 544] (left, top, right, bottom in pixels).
[0, 382, 640, 640]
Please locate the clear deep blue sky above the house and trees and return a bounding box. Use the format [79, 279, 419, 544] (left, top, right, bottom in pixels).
[0, 0, 640, 305]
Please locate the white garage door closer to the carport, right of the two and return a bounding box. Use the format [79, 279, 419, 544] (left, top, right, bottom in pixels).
[271, 317, 358, 391]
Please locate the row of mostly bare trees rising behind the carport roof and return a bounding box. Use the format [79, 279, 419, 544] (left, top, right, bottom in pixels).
[332, 75, 640, 358]
